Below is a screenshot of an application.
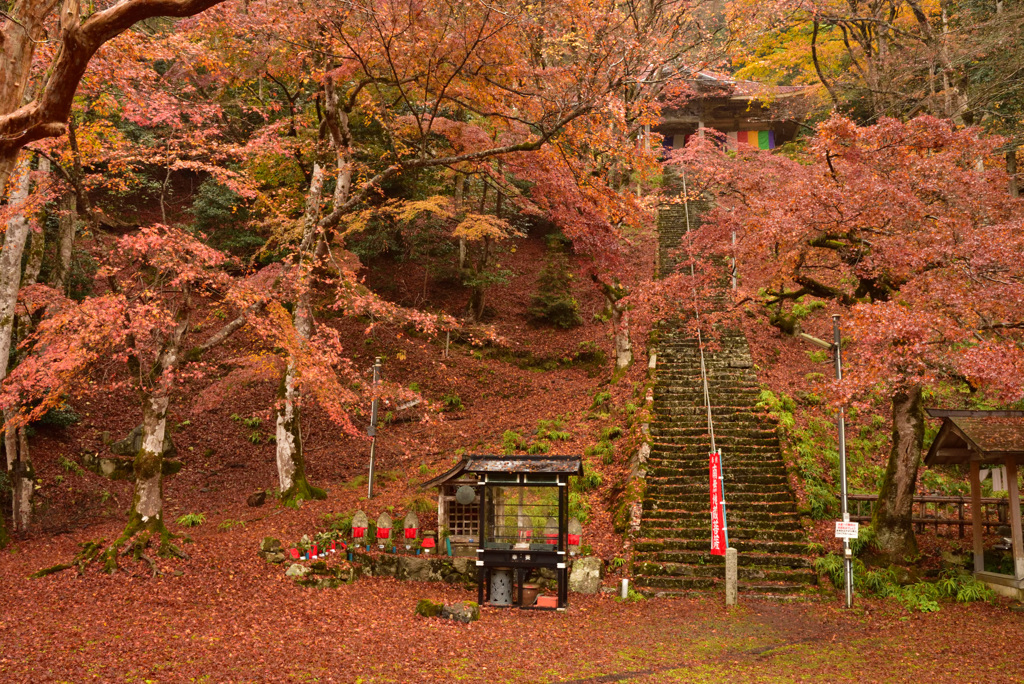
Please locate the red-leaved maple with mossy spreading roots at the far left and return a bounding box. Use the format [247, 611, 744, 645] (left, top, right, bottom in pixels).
[3, 226, 267, 570]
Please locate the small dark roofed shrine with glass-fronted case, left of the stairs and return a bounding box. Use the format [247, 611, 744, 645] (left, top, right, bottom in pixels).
[423, 455, 583, 609]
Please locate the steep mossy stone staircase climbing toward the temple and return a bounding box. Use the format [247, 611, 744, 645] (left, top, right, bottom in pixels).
[634, 196, 816, 595]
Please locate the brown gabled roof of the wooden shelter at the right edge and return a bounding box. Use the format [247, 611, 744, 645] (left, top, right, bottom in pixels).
[925, 409, 1024, 465]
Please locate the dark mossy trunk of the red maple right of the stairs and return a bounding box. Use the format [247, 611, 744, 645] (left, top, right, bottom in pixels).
[871, 385, 925, 562]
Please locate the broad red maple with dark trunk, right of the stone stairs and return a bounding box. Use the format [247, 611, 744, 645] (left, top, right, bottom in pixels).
[676, 116, 1024, 559]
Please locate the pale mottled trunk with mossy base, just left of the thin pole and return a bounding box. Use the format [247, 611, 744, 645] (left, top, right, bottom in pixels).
[276, 159, 323, 506]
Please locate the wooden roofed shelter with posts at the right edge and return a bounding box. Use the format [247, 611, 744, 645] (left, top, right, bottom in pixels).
[925, 409, 1024, 598]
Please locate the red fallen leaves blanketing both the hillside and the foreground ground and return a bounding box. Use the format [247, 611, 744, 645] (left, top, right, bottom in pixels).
[8, 231, 1024, 684]
